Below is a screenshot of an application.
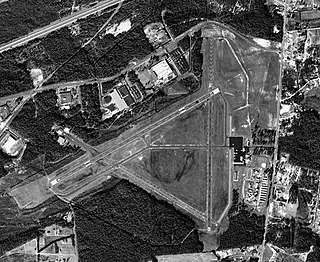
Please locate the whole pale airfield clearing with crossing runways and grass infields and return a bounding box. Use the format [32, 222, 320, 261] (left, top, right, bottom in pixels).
[11, 22, 280, 231]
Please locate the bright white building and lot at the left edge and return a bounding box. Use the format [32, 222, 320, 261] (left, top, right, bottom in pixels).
[0, 131, 25, 156]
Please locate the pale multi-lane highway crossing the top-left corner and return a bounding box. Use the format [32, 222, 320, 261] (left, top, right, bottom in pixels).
[0, 0, 124, 53]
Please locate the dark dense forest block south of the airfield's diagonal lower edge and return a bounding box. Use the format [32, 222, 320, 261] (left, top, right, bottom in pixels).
[73, 180, 203, 262]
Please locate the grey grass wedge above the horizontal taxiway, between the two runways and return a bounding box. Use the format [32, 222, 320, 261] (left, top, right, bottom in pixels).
[151, 105, 208, 145]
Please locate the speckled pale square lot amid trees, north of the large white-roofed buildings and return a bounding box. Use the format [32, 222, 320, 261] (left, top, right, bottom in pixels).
[143, 23, 169, 47]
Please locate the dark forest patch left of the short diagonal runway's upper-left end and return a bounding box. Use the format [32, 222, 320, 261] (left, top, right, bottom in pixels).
[10, 90, 79, 174]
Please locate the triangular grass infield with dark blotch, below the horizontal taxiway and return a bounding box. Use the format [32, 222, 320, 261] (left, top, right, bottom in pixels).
[125, 148, 207, 212]
